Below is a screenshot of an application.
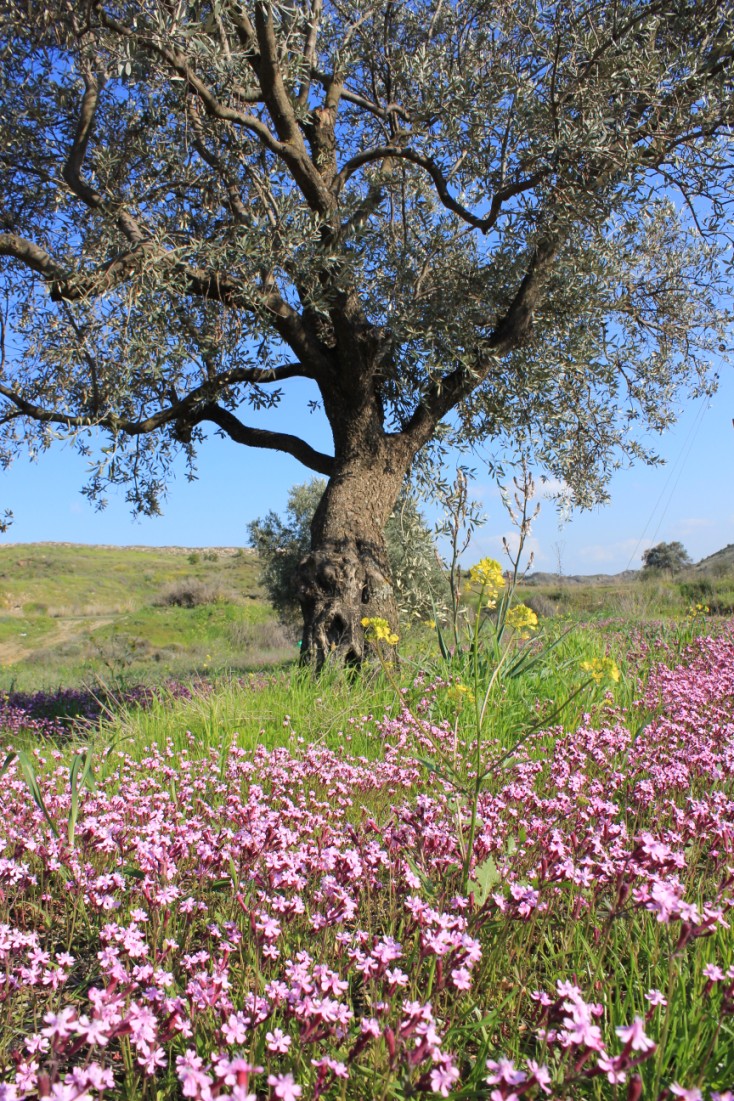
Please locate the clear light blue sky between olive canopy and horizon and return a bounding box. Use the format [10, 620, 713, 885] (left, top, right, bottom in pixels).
[0, 368, 734, 574]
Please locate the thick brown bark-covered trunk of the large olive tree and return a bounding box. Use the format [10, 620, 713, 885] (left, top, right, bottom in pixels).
[298, 437, 408, 668]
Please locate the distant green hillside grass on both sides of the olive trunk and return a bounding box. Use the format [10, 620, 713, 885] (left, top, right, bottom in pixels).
[0, 544, 734, 691]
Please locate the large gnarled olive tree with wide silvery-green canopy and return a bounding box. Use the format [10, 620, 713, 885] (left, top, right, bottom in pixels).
[0, 0, 734, 663]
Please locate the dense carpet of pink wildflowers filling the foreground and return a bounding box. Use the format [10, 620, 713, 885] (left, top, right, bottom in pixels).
[0, 631, 734, 1101]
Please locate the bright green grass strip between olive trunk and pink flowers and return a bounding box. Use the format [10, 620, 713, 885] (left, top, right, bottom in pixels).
[53, 609, 634, 779]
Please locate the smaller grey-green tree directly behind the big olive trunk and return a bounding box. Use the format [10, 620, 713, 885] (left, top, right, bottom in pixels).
[248, 478, 448, 622]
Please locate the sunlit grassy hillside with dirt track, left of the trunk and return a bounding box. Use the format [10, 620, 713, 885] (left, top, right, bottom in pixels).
[0, 544, 290, 690]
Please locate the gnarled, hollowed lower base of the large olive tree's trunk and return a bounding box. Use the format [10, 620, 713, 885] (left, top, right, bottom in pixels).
[298, 538, 397, 668]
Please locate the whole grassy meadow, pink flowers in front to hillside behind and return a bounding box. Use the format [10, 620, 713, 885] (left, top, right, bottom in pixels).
[0, 546, 734, 1101]
